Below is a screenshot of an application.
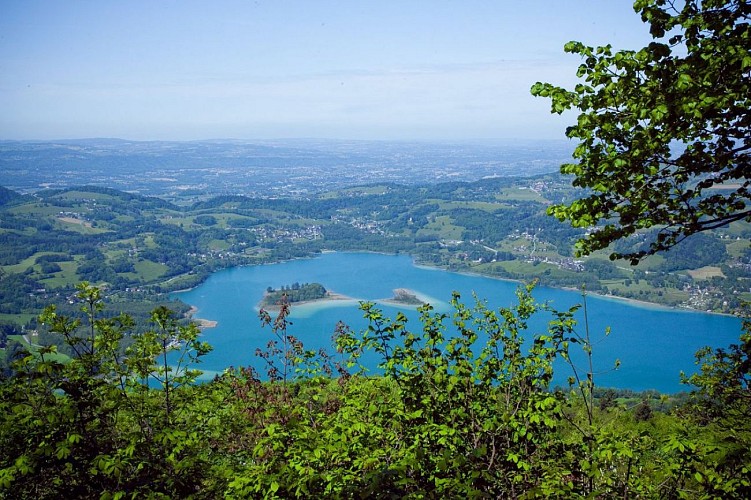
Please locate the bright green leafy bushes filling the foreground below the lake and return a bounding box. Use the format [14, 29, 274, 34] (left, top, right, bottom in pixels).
[0, 283, 751, 498]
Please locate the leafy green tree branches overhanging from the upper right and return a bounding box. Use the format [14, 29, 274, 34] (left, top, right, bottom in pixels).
[532, 0, 751, 264]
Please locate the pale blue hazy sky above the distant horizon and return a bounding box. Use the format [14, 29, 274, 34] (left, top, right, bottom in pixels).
[0, 0, 649, 141]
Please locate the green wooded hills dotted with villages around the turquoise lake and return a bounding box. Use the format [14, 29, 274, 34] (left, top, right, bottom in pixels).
[0, 171, 751, 336]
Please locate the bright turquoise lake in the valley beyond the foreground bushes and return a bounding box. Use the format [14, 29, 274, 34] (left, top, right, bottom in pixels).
[173, 253, 741, 393]
